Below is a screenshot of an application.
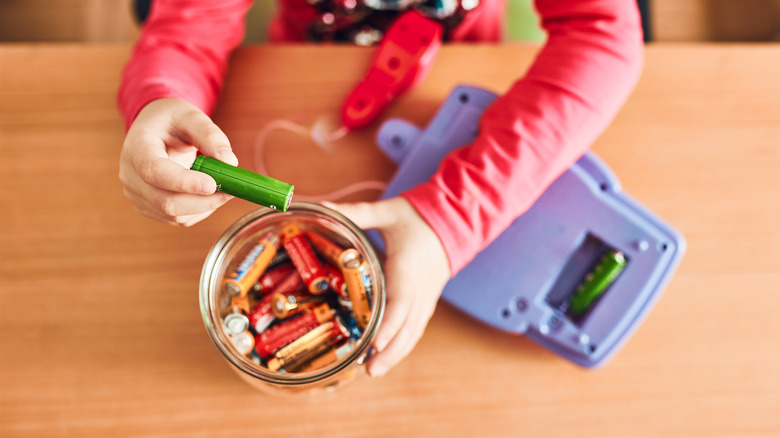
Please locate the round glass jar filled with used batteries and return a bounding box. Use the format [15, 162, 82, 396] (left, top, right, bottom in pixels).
[200, 202, 385, 394]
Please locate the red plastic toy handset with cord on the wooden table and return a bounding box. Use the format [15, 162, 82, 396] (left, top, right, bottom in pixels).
[341, 10, 443, 129]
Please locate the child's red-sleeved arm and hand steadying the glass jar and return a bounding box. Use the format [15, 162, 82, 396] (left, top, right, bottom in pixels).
[336, 0, 643, 375]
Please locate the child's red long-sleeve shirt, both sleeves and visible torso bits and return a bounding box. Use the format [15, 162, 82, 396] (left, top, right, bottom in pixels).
[118, 0, 643, 275]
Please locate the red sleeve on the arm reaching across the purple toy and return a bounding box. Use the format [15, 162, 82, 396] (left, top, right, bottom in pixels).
[403, 0, 643, 275]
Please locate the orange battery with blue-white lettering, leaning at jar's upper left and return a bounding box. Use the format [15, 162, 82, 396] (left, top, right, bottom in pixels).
[222, 231, 279, 296]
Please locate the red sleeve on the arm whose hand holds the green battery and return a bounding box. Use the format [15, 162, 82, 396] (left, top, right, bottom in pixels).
[117, 0, 252, 128]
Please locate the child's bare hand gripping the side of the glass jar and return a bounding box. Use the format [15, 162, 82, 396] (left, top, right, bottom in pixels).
[328, 197, 450, 376]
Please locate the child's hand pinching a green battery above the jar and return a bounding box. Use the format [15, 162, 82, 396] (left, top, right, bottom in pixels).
[119, 99, 238, 226]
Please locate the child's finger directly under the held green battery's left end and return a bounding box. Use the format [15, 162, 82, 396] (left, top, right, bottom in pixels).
[133, 154, 217, 195]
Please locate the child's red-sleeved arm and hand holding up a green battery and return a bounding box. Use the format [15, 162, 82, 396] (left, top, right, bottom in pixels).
[118, 0, 251, 226]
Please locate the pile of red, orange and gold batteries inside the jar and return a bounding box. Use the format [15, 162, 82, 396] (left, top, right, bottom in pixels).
[220, 221, 373, 373]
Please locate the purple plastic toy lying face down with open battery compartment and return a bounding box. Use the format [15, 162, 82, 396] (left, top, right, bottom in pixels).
[370, 86, 685, 367]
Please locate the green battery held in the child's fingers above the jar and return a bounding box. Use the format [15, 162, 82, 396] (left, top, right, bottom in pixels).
[192, 155, 295, 211]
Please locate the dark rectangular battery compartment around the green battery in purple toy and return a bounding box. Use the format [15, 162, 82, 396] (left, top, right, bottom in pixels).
[546, 233, 629, 325]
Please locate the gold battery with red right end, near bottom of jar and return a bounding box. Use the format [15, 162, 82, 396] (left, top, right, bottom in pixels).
[268, 318, 349, 371]
